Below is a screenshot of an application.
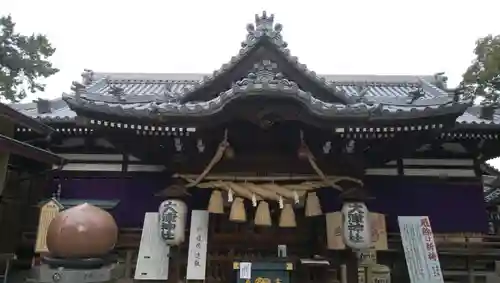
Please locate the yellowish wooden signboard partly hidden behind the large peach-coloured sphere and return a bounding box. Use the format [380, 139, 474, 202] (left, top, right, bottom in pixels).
[35, 199, 62, 253]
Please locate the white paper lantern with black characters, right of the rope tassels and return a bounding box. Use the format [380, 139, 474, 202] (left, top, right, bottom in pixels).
[342, 202, 372, 250]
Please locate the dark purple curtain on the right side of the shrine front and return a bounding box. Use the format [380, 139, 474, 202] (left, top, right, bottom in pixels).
[319, 178, 488, 233]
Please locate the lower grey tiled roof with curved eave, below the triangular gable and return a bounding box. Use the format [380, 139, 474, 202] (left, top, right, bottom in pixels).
[66, 67, 472, 124]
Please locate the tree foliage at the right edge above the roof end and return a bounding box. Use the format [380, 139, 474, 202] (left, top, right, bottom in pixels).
[463, 35, 500, 97]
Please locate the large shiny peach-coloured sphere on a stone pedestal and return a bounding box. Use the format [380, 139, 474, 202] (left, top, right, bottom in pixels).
[47, 203, 118, 258]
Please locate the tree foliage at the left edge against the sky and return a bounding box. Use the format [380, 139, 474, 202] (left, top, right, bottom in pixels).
[0, 15, 59, 102]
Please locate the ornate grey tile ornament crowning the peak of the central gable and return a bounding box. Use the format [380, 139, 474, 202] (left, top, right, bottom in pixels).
[241, 11, 288, 48]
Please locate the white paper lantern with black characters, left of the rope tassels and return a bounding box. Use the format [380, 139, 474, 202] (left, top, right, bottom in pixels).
[159, 199, 187, 246]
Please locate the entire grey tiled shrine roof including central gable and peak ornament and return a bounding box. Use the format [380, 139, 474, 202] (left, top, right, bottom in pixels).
[5, 13, 486, 125]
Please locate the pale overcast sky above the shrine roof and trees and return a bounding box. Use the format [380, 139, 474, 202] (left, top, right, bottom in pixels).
[0, 0, 500, 100]
